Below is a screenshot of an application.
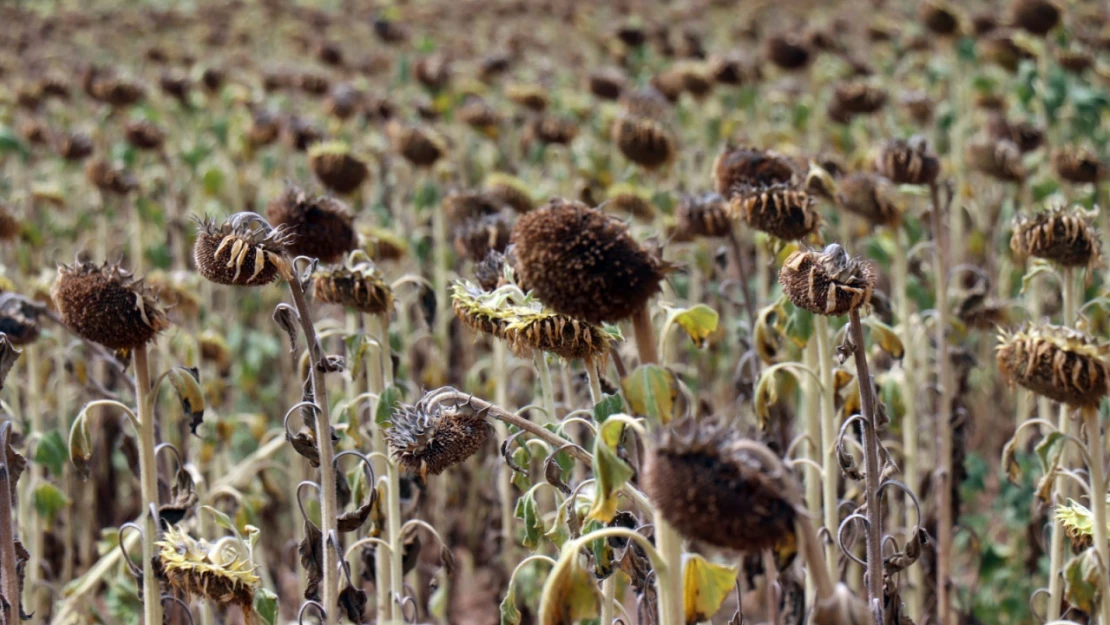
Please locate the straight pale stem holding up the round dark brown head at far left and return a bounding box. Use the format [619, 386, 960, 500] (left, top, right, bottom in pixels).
[133, 345, 162, 625]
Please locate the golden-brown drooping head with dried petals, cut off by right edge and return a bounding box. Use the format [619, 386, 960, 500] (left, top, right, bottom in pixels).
[997, 324, 1110, 406]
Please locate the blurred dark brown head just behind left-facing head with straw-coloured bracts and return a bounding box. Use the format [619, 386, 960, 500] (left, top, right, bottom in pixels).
[266, 184, 359, 263]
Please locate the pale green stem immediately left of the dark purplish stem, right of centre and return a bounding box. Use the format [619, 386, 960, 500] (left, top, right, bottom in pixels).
[814, 314, 840, 579]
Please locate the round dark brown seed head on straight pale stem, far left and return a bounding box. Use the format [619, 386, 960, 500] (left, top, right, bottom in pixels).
[50, 256, 170, 350]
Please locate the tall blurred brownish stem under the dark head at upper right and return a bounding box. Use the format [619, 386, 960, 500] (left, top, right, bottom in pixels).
[929, 182, 955, 625]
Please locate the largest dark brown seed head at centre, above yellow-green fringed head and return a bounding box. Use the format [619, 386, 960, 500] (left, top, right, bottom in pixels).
[512, 199, 664, 324]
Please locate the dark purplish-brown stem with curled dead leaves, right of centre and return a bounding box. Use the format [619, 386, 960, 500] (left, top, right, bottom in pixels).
[848, 309, 884, 625]
